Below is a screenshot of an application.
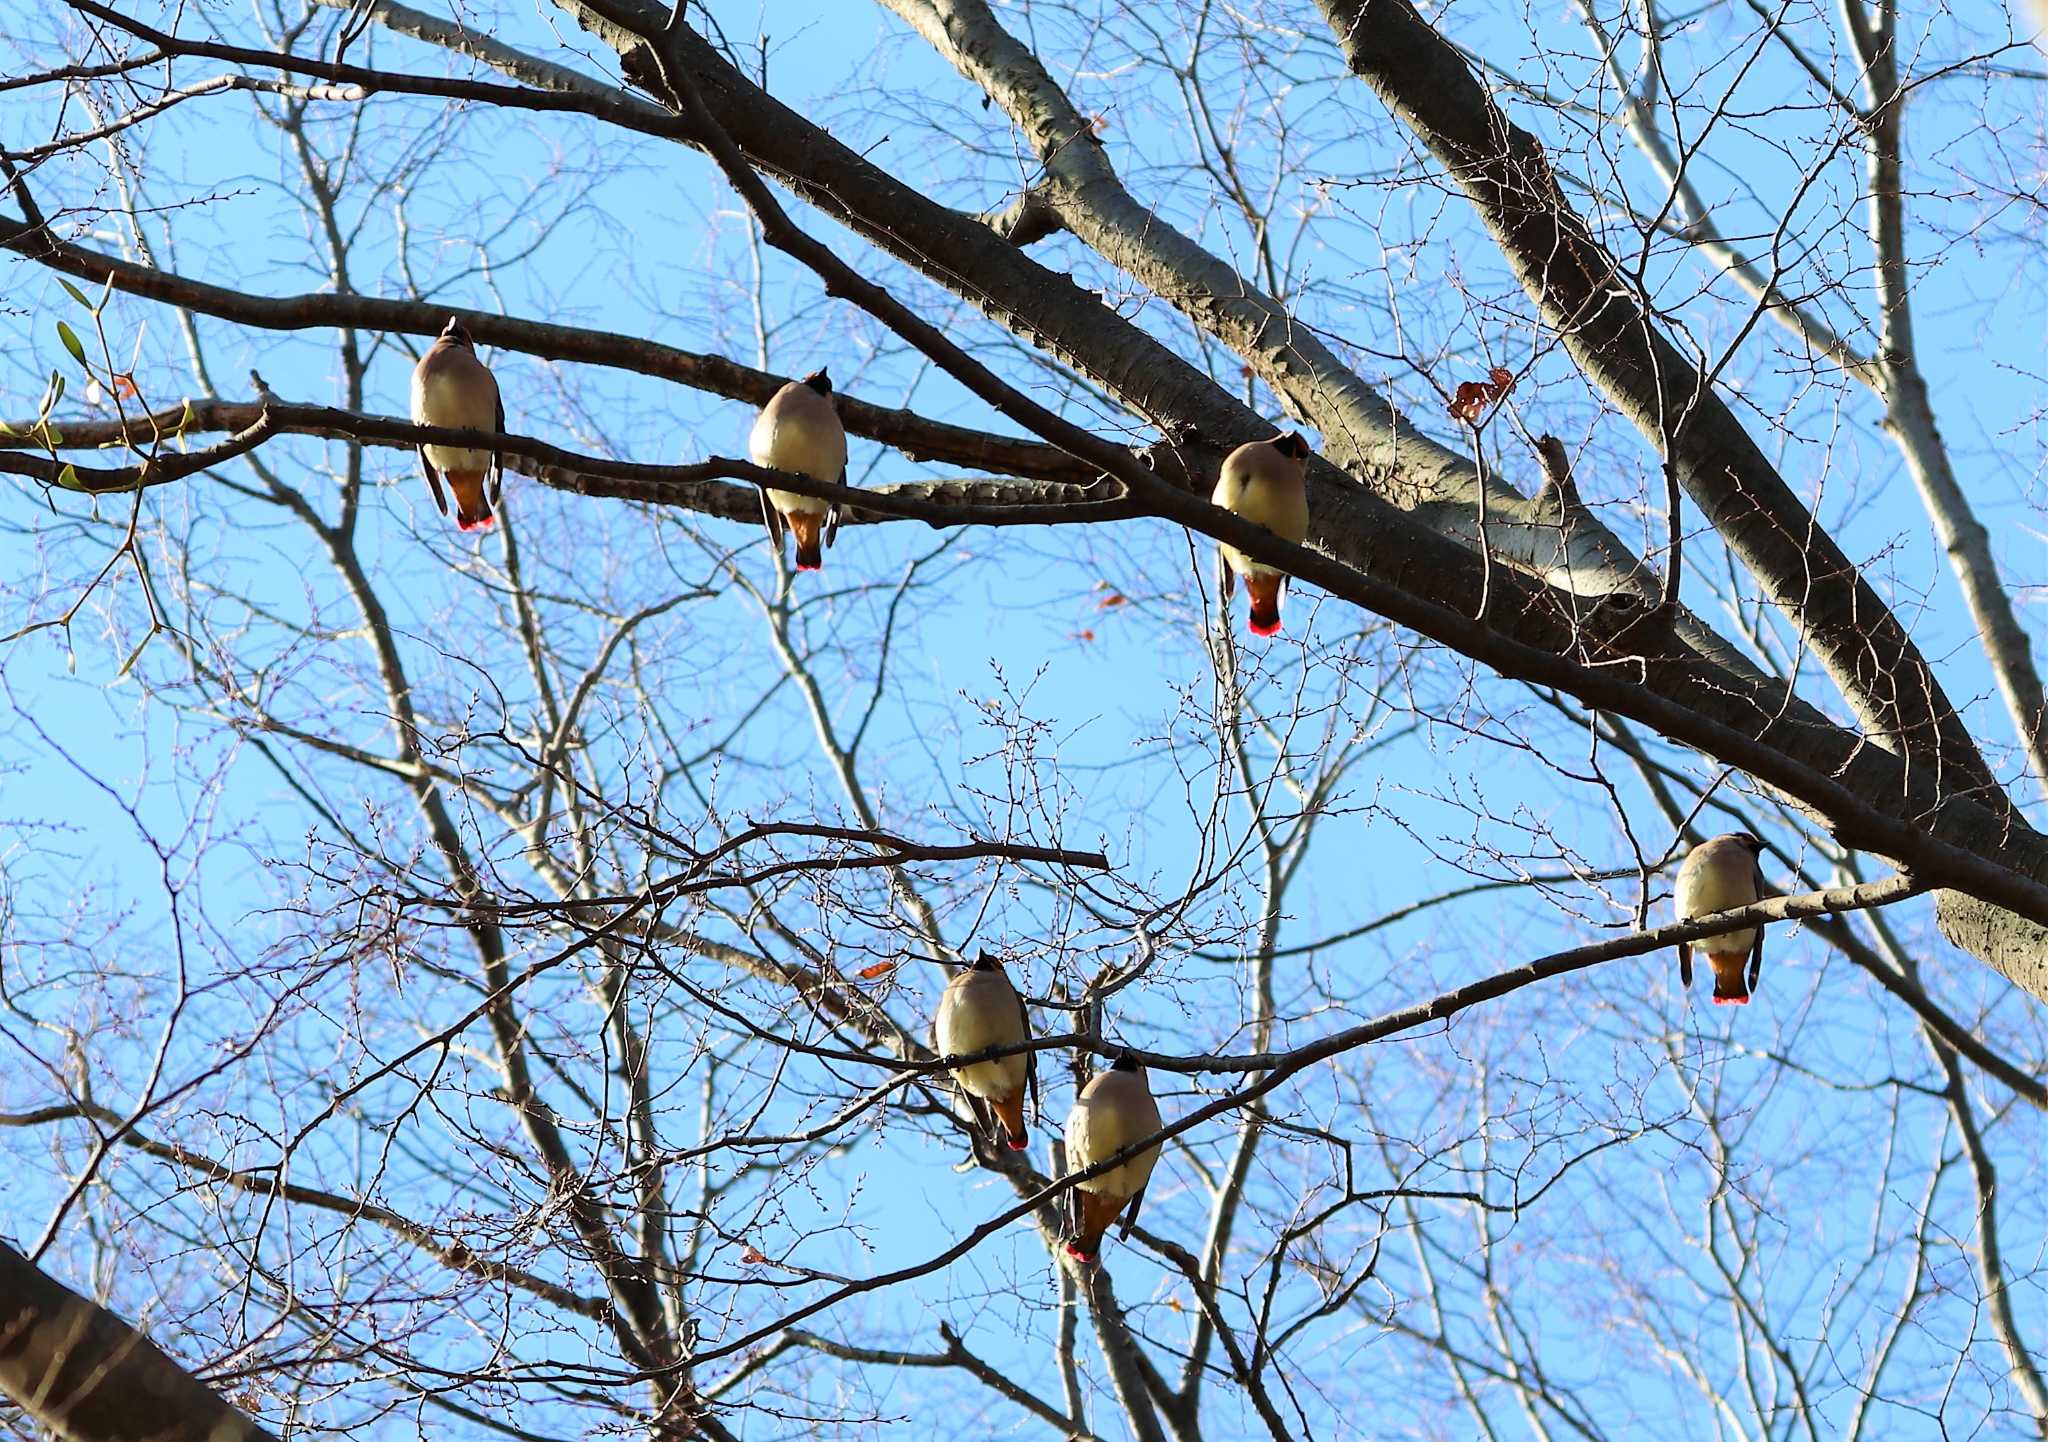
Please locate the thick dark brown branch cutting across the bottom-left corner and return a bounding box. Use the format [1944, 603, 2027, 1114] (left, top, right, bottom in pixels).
[0, 1241, 274, 1442]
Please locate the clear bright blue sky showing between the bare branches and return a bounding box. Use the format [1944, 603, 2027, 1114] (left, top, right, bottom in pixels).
[0, 4, 2048, 1436]
